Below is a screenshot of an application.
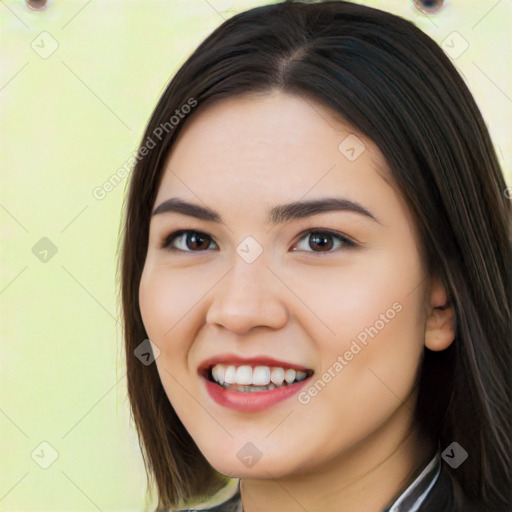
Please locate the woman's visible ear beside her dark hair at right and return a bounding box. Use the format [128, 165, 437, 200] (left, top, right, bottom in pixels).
[425, 277, 456, 352]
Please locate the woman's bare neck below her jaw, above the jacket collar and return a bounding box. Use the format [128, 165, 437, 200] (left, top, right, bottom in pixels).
[240, 403, 433, 512]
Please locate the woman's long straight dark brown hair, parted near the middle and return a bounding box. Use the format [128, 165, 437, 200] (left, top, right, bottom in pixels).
[120, 1, 512, 510]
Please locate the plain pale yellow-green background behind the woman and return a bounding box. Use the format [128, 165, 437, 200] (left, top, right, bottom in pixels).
[0, 0, 512, 512]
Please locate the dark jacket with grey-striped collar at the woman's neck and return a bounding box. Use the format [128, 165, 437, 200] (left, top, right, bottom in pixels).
[177, 453, 512, 512]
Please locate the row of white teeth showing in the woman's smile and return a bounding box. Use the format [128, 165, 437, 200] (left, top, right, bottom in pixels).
[211, 364, 308, 391]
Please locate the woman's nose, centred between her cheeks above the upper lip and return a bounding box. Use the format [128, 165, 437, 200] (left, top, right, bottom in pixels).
[206, 256, 288, 335]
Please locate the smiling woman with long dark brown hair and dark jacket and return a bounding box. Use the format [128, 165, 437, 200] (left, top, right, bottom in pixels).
[121, 2, 512, 512]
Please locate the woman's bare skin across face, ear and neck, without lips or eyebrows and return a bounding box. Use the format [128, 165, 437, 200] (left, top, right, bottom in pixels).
[139, 92, 454, 512]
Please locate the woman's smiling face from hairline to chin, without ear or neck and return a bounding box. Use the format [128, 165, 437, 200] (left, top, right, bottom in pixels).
[139, 93, 427, 478]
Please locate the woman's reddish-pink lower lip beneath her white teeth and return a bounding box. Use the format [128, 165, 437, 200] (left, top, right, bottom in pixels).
[203, 377, 311, 412]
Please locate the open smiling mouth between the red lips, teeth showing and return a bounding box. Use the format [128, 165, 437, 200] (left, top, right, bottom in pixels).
[203, 364, 314, 393]
